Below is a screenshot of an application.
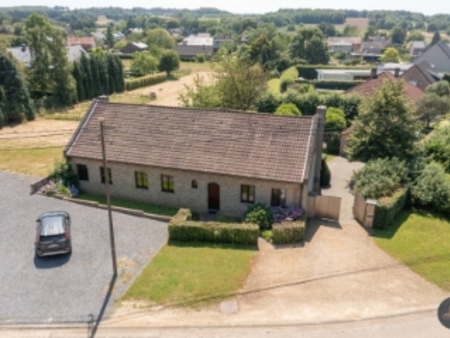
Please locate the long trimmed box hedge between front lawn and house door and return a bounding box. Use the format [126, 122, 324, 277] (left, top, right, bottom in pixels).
[169, 209, 259, 246]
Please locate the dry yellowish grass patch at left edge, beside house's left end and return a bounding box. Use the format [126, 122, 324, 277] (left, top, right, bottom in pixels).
[0, 147, 63, 177]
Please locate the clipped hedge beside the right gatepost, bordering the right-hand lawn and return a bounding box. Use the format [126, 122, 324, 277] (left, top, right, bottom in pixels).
[372, 188, 409, 229]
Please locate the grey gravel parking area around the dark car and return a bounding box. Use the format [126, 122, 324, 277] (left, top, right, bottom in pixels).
[0, 171, 168, 324]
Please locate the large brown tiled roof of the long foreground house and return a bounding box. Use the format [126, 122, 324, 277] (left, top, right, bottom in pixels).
[65, 101, 315, 183]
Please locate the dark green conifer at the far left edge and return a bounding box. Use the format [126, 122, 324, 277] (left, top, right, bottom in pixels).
[0, 53, 36, 125]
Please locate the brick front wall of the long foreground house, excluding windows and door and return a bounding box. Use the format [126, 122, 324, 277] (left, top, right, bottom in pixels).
[70, 158, 302, 217]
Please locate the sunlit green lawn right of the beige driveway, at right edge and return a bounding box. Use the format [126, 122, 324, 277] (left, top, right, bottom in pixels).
[374, 211, 450, 291]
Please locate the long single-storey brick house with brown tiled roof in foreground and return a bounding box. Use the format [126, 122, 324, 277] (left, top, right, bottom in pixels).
[64, 98, 326, 217]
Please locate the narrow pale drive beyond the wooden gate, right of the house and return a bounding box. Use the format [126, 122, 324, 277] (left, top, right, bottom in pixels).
[322, 156, 364, 224]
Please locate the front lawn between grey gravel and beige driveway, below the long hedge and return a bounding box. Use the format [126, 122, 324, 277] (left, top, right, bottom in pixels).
[122, 243, 256, 306]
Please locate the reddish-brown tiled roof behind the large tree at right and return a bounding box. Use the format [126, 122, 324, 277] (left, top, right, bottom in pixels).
[345, 72, 425, 100]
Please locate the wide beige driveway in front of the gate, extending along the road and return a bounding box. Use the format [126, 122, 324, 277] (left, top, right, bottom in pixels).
[108, 221, 449, 326]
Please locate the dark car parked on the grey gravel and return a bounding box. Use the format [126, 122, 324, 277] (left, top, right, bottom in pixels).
[35, 211, 72, 257]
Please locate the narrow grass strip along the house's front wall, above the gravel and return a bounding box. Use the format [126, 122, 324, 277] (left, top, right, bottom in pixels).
[77, 193, 178, 216]
